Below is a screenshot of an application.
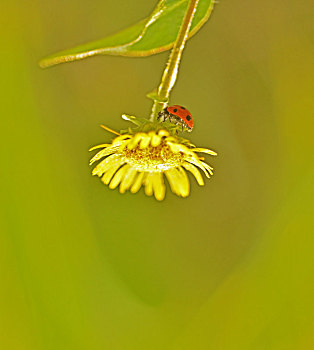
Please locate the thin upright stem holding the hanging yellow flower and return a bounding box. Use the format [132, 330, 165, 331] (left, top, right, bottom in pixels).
[150, 0, 199, 121]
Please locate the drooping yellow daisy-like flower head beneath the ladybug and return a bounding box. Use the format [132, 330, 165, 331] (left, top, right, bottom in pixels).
[90, 123, 216, 201]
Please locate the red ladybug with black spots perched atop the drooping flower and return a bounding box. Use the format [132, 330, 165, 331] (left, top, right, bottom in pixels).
[157, 105, 193, 132]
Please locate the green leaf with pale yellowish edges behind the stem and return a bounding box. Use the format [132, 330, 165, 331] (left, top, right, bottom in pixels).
[39, 0, 214, 68]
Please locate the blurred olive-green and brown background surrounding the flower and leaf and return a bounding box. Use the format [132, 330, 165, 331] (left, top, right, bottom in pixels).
[0, 0, 314, 350]
